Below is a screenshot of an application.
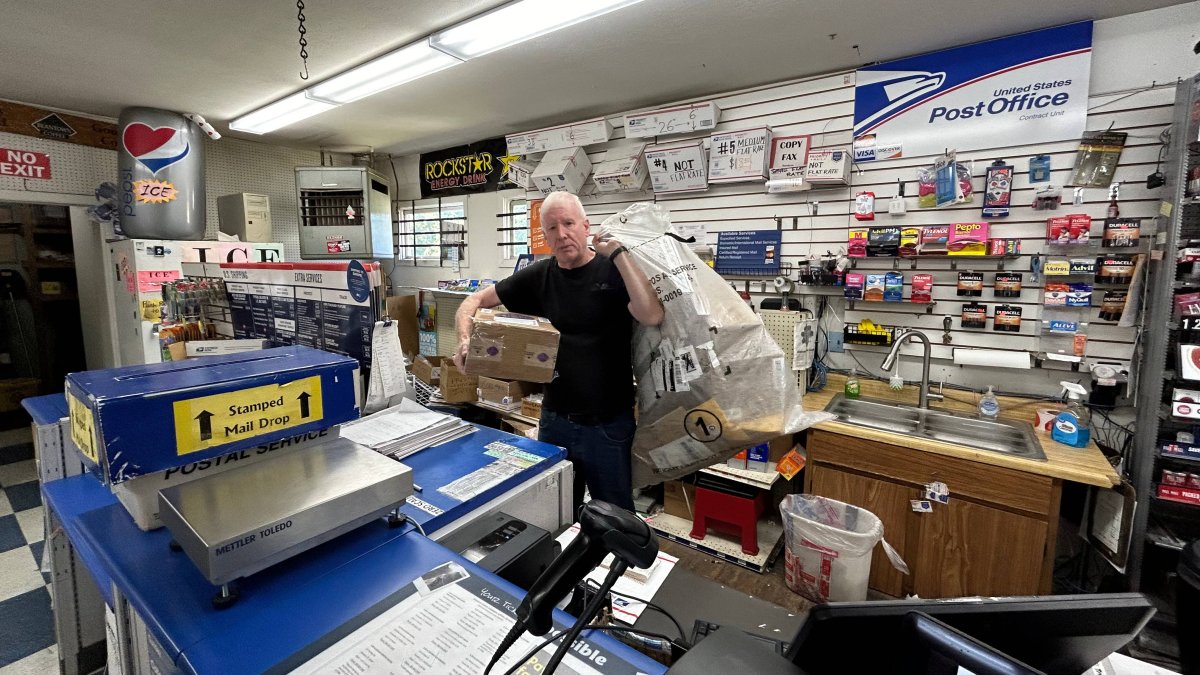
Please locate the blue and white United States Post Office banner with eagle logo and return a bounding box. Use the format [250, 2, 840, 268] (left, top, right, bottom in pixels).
[854, 22, 1092, 161]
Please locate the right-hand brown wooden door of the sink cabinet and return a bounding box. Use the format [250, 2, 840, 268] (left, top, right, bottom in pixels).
[908, 495, 1048, 598]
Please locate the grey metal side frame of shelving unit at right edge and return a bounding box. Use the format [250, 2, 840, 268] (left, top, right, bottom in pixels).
[1127, 76, 1200, 590]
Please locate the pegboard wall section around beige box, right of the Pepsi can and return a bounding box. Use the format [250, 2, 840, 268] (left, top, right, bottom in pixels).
[204, 137, 320, 261]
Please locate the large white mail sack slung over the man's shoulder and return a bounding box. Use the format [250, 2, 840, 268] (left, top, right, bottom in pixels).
[596, 203, 833, 488]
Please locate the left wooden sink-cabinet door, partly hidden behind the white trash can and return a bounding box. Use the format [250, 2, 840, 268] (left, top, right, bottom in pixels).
[808, 466, 917, 590]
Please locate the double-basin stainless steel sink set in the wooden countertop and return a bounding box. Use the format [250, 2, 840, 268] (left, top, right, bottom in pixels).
[826, 394, 1046, 461]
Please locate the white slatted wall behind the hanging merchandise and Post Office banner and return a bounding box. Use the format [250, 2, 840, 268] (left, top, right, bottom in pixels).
[394, 2, 1200, 394]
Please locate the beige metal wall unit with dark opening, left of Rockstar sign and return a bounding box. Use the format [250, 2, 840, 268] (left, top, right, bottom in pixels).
[296, 167, 396, 259]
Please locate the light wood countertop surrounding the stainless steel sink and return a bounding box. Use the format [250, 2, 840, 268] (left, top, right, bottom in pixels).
[804, 374, 1121, 488]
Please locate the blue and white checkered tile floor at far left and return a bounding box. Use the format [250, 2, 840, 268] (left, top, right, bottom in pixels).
[0, 429, 59, 675]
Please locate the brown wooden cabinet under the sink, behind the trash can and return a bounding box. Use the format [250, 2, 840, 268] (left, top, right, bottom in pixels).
[804, 430, 1062, 598]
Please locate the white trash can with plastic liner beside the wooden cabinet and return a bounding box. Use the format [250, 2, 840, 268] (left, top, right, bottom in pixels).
[779, 495, 908, 603]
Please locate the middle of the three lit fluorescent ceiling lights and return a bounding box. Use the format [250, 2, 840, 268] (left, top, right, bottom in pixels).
[306, 40, 462, 103]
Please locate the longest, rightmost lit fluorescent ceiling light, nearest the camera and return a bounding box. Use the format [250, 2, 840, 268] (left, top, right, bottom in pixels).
[430, 0, 641, 60]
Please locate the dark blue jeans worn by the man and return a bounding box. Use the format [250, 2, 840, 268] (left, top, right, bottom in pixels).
[538, 410, 637, 516]
